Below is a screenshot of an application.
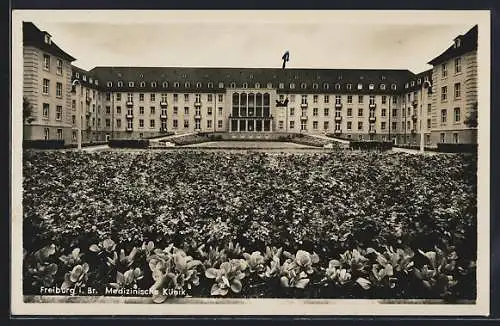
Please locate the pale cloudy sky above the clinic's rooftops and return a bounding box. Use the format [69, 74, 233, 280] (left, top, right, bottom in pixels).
[19, 11, 474, 73]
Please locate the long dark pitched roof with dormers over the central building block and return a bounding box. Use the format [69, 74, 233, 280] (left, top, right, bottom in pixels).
[90, 67, 414, 92]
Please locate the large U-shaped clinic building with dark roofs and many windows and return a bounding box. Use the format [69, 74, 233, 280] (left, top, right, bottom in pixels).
[23, 22, 478, 146]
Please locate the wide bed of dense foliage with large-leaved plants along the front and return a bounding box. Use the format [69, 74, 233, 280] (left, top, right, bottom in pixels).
[23, 151, 477, 302]
